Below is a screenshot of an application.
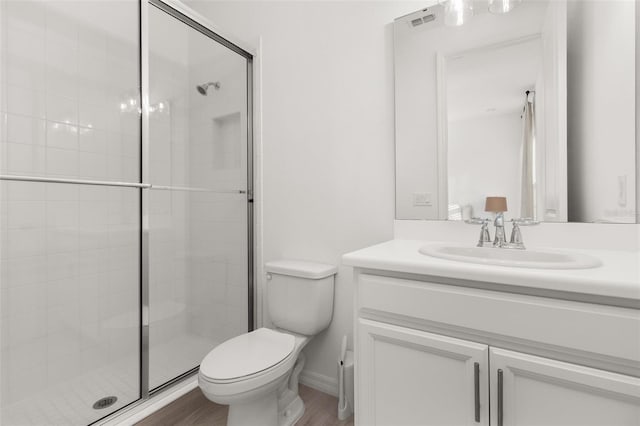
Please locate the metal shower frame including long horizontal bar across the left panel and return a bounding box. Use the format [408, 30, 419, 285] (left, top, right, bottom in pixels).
[0, 0, 255, 424]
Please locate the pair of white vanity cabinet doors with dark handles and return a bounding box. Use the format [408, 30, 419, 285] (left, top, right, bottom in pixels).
[358, 319, 640, 426]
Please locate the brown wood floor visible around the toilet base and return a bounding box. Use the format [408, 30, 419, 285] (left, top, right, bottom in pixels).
[137, 385, 353, 426]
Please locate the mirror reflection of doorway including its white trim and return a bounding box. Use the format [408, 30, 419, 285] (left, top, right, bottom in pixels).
[436, 2, 567, 225]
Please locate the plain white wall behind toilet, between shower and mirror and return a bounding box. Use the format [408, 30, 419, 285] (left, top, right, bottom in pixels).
[189, 1, 421, 392]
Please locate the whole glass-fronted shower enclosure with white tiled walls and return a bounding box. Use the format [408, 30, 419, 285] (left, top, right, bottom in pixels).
[0, 0, 253, 425]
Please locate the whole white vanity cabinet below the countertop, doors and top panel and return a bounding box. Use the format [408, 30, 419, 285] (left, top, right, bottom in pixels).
[355, 269, 640, 426]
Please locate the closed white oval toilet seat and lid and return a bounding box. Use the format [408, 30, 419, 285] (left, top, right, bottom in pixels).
[200, 328, 295, 383]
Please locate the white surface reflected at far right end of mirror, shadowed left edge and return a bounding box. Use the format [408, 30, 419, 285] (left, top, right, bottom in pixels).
[568, 1, 637, 222]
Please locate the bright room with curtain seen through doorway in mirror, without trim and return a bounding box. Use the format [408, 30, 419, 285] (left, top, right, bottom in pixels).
[439, 34, 543, 220]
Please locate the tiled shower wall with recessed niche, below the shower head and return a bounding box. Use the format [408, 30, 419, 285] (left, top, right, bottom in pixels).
[189, 49, 248, 342]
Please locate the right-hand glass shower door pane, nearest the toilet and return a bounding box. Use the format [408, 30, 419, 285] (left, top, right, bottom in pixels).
[147, 2, 249, 390]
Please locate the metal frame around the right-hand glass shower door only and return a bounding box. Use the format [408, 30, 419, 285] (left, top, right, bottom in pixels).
[140, 0, 255, 401]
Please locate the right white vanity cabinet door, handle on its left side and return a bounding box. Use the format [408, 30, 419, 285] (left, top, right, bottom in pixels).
[489, 348, 640, 426]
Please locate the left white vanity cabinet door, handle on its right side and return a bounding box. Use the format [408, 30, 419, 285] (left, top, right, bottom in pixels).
[355, 319, 489, 426]
